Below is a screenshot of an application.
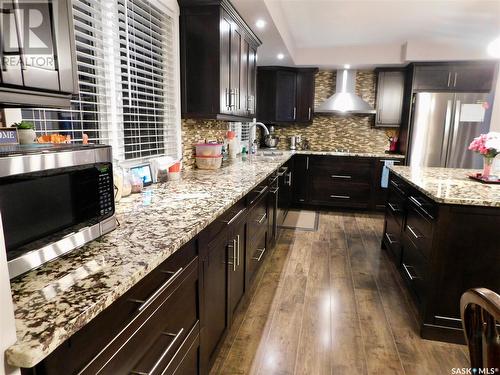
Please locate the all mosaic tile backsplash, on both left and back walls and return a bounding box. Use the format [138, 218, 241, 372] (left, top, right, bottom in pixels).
[182, 71, 388, 168]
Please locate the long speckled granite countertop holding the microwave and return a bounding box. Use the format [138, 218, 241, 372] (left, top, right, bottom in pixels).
[6, 151, 402, 367]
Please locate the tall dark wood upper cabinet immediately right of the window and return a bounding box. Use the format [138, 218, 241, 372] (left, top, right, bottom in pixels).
[179, 0, 261, 121]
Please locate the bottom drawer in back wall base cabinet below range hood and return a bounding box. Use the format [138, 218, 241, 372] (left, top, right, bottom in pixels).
[310, 177, 371, 207]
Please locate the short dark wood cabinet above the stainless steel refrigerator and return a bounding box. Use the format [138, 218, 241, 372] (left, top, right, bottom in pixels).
[413, 62, 497, 92]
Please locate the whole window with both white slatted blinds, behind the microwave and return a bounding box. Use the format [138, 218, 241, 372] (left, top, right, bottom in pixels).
[22, 0, 180, 161]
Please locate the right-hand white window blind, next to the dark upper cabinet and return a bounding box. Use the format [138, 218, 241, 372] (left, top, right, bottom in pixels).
[118, 0, 177, 159]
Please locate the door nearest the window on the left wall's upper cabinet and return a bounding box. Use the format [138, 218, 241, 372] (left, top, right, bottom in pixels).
[220, 12, 231, 114]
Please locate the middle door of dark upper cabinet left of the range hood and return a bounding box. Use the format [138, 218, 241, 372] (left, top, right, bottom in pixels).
[276, 71, 297, 122]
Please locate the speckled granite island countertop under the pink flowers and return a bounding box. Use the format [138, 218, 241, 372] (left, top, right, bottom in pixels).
[390, 166, 500, 207]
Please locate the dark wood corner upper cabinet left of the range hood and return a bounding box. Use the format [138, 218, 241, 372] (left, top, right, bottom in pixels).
[257, 66, 317, 123]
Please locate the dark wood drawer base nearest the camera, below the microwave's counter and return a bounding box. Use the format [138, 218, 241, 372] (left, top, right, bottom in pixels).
[22, 239, 200, 375]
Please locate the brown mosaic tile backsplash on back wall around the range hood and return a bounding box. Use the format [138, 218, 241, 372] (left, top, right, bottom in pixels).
[275, 71, 388, 153]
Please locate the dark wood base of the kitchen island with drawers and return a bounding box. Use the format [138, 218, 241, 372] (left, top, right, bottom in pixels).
[382, 173, 500, 343]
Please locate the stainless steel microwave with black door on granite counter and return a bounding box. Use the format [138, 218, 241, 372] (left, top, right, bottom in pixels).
[0, 144, 116, 279]
